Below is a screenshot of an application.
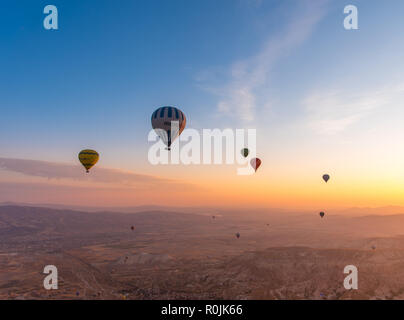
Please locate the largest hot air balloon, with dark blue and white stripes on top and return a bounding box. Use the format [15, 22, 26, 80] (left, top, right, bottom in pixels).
[151, 107, 187, 150]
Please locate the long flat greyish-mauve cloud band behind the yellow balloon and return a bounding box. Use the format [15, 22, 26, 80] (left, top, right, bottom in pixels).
[0, 158, 200, 189]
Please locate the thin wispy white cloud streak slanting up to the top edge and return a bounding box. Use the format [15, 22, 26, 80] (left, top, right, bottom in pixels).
[205, 0, 328, 122]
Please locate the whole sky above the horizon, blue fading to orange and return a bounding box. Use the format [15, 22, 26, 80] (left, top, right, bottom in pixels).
[0, 0, 404, 210]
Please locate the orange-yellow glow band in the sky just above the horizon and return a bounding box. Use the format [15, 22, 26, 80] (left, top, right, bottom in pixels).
[0, 167, 404, 210]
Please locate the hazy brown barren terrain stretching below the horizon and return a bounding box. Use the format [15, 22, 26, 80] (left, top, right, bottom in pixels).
[0, 205, 404, 299]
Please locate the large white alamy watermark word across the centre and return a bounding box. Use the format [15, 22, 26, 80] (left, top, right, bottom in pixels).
[148, 121, 257, 175]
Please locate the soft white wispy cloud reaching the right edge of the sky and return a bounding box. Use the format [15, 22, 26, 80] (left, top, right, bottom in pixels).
[303, 83, 404, 134]
